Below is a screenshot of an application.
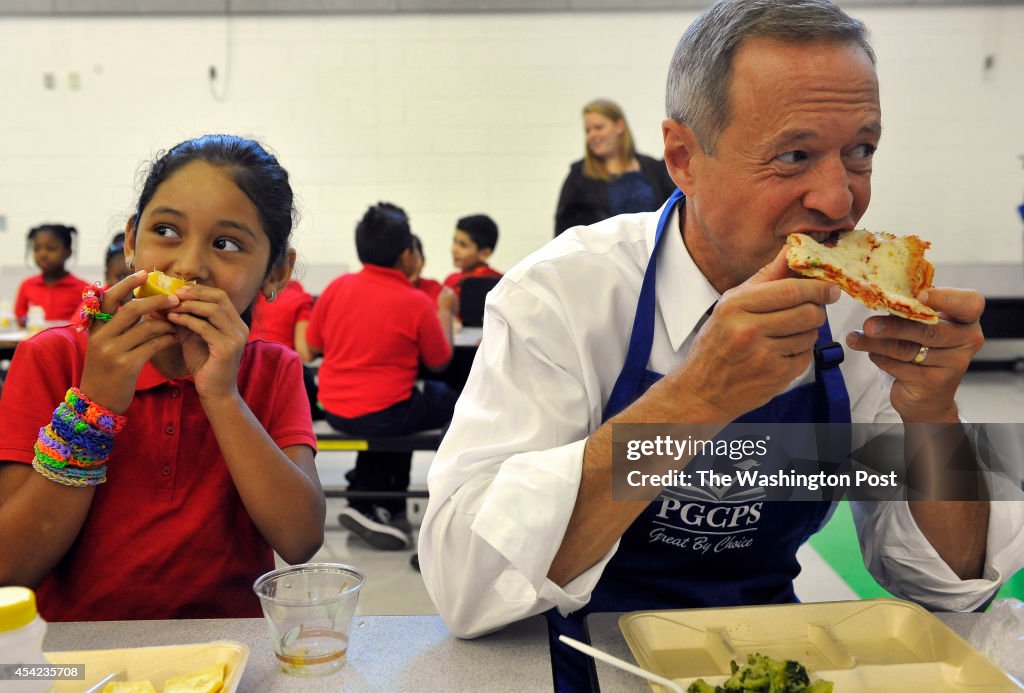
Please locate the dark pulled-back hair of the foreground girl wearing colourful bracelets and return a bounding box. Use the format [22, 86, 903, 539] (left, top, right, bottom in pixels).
[131, 135, 297, 272]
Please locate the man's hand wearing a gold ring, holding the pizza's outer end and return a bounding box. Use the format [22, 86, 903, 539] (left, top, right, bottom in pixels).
[847, 289, 985, 423]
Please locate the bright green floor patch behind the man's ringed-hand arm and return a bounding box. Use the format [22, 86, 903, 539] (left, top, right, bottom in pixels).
[811, 501, 1024, 601]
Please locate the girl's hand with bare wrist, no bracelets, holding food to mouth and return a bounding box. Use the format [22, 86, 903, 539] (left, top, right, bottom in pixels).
[167, 284, 249, 399]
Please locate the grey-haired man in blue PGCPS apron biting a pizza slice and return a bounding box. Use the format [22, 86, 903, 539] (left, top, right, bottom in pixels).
[419, 0, 1024, 690]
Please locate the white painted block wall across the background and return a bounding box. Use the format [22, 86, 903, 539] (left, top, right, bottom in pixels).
[0, 6, 1024, 296]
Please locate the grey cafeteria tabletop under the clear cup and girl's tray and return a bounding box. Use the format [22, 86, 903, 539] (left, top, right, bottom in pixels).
[43, 615, 552, 693]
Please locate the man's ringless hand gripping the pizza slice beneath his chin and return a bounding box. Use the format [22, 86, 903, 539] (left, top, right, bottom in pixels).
[670, 248, 840, 422]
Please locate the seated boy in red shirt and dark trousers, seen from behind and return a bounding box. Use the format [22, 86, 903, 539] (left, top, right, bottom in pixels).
[306, 203, 457, 551]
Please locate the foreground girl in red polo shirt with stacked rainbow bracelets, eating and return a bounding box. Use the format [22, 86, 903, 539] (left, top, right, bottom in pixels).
[0, 135, 325, 620]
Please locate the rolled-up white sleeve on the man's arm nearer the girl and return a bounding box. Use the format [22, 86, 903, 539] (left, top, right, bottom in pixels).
[419, 281, 614, 638]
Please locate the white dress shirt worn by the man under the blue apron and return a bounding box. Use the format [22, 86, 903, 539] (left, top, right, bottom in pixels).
[419, 203, 1024, 638]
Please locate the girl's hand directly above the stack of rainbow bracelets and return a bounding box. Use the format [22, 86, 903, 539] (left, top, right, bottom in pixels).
[79, 270, 180, 414]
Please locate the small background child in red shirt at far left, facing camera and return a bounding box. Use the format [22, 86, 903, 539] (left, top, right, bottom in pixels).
[14, 224, 89, 324]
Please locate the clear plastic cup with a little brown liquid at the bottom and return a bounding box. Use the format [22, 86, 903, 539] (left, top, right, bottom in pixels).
[253, 563, 366, 677]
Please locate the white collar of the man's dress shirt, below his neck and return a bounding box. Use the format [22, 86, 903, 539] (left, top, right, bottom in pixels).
[647, 202, 721, 351]
